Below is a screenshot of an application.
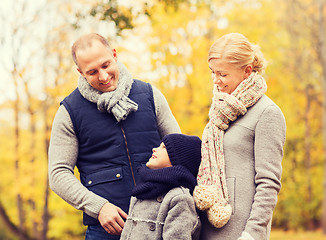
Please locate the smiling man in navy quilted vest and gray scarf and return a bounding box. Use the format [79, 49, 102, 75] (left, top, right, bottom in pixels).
[49, 34, 180, 240]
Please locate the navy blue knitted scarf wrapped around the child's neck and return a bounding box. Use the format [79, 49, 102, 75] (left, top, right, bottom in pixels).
[131, 165, 197, 200]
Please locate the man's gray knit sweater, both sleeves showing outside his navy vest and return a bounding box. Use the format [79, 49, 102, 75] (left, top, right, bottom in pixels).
[48, 87, 181, 219]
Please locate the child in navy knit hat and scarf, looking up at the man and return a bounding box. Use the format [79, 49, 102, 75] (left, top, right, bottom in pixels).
[120, 134, 201, 240]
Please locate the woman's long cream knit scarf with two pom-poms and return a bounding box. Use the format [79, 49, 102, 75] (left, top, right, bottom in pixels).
[193, 72, 267, 228]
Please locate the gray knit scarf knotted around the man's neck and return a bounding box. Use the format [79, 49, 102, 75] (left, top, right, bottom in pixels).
[78, 62, 138, 122]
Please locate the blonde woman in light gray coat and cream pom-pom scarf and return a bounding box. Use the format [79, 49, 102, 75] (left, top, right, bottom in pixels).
[194, 33, 285, 240]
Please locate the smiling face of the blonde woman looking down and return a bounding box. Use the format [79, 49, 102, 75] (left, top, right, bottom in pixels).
[208, 58, 252, 94]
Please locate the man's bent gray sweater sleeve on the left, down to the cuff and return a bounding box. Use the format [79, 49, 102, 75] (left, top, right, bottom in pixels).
[48, 105, 107, 219]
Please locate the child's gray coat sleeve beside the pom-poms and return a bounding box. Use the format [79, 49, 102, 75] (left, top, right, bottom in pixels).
[162, 194, 201, 240]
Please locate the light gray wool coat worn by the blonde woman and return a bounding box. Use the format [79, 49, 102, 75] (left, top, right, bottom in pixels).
[201, 95, 286, 240]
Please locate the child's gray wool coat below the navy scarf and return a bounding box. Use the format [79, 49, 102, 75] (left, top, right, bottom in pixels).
[120, 187, 201, 240]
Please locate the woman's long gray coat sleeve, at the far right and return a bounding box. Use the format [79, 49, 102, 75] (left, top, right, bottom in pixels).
[240, 105, 286, 239]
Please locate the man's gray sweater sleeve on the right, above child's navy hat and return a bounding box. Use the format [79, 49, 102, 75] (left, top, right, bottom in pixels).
[153, 86, 181, 138]
